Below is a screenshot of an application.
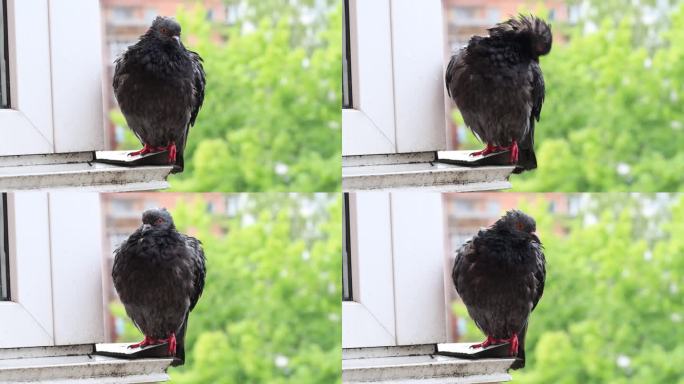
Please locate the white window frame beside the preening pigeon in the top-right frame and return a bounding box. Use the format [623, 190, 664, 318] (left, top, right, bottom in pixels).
[342, 0, 447, 156]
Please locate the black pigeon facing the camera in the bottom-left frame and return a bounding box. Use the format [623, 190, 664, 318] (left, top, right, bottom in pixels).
[112, 209, 206, 365]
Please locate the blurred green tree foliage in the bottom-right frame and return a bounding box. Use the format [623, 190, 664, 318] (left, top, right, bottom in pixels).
[459, 194, 684, 384]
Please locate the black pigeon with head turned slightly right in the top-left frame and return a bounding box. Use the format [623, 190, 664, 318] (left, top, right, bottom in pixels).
[113, 17, 205, 172]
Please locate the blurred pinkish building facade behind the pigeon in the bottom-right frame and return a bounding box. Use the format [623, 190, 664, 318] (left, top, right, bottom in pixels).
[442, 192, 581, 341]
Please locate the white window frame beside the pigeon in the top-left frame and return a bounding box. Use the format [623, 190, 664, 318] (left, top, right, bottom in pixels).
[0, 0, 104, 156]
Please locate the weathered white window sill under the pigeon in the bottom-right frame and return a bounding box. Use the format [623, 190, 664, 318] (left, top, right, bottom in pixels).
[342, 345, 514, 384]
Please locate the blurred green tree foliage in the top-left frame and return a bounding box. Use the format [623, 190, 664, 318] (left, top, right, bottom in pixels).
[115, 4, 342, 192]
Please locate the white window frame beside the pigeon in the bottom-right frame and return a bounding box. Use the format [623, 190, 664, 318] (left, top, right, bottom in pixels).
[342, 192, 447, 348]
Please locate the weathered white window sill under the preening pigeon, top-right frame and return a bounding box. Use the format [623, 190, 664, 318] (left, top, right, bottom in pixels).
[342, 151, 514, 192]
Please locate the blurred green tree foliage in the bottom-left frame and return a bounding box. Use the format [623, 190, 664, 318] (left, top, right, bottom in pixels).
[114, 194, 342, 384]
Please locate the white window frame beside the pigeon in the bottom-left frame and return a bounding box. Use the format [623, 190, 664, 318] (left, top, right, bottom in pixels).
[0, 192, 104, 348]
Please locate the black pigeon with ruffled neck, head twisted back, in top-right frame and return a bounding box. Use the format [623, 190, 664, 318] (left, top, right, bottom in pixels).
[445, 15, 553, 173]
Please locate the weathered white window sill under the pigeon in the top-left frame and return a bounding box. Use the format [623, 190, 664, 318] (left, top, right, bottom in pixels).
[0, 152, 172, 192]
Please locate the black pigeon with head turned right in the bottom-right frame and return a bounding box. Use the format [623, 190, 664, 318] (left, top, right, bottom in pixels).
[451, 210, 546, 369]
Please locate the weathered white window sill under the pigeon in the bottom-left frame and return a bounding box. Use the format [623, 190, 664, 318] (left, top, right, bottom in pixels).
[0, 345, 172, 384]
